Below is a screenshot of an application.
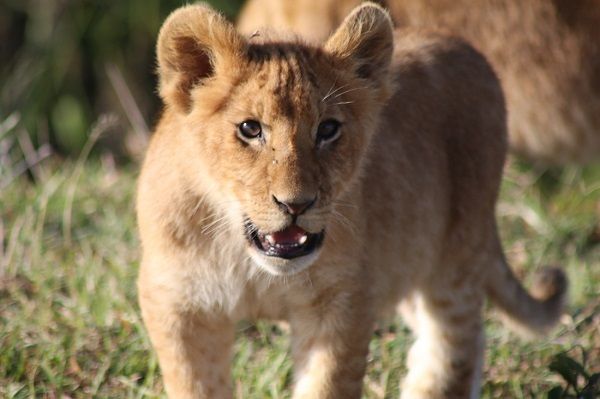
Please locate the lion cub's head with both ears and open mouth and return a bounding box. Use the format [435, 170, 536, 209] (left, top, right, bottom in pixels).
[158, 4, 393, 274]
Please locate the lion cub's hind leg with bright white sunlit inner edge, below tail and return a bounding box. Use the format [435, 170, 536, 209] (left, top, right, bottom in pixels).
[401, 276, 484, 399]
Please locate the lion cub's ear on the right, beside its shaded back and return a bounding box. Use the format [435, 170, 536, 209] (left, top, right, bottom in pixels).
[325, 2, 394, 92]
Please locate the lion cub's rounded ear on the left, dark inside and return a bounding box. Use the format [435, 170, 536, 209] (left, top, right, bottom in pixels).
[156, 4, 245, 112]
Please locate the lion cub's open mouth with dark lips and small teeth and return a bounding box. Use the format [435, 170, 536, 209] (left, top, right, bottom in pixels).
[244, 219, 325, 259]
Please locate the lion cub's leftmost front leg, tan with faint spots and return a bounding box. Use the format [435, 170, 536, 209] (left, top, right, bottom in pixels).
[139, 290, 234, 399]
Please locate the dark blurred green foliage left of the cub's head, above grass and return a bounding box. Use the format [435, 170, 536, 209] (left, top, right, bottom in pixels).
[0, 0, 242, 162]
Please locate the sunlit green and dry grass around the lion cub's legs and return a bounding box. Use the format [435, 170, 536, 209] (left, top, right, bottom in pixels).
[0, 155, 600, 398]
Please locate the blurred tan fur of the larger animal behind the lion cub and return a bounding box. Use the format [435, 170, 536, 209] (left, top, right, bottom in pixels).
[238, 0, 600, 164]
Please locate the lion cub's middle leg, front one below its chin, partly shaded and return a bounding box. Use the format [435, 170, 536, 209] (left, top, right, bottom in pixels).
[291, 295, 373, 399]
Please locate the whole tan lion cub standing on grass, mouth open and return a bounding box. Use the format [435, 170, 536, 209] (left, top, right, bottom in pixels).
[137, 3, 565, 399]
